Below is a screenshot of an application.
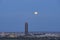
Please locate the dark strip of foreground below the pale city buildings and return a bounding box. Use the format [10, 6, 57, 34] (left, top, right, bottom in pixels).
[0, 37, 60, 40]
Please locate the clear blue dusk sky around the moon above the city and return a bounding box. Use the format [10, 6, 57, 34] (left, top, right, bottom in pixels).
[0, 0, 60, 32]
